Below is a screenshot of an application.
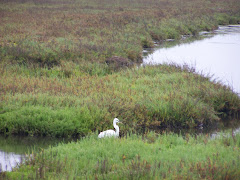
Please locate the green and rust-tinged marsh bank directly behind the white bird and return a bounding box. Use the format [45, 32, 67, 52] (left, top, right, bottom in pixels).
[0, 65, 240, 137]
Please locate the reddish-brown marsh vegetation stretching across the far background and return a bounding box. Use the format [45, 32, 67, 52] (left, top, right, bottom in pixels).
[0, 0, 240, 70]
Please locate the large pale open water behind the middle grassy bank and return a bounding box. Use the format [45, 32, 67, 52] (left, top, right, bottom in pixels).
[143, 25, 240, 94]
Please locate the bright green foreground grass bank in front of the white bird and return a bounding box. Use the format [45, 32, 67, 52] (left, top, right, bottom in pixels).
[2, 133, 240, 179]
